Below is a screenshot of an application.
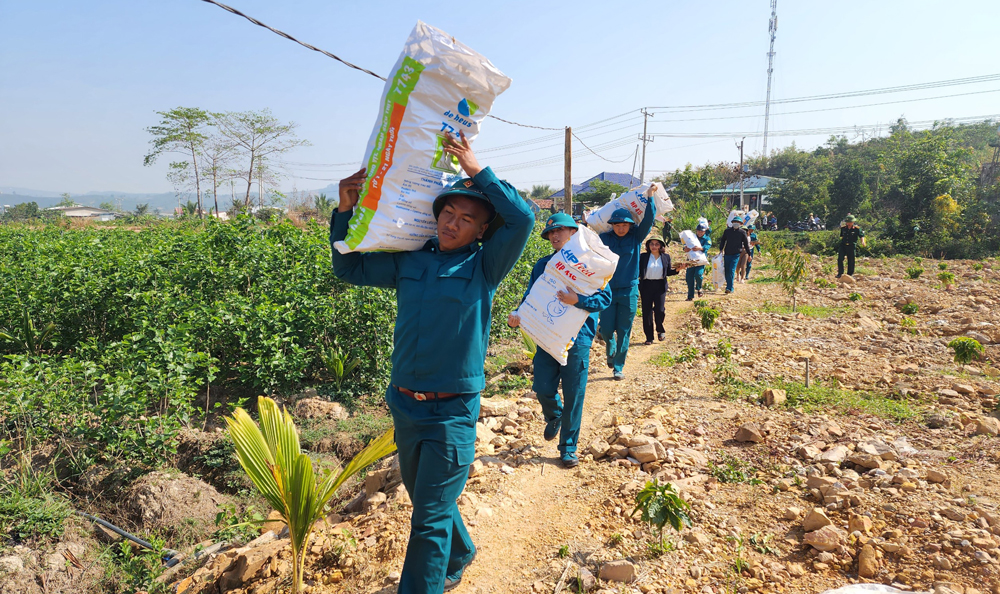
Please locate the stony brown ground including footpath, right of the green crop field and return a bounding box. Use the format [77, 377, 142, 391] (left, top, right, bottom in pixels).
[0, 251, 1000, 594]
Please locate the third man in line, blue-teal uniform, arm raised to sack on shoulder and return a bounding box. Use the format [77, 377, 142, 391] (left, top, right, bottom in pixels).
[599, 184, 656, 380]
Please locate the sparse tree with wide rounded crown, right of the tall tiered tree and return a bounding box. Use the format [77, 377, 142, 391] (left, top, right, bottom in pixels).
[213, 109, 309, 210]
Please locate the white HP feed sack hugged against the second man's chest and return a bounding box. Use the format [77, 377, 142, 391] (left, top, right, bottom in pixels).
[514, 227, 618, 365]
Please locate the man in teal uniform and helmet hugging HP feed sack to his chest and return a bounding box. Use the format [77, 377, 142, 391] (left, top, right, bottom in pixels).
[507, 212, 611, 468]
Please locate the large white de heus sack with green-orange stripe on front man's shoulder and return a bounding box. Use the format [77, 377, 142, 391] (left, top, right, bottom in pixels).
[335, 21, 510, 254]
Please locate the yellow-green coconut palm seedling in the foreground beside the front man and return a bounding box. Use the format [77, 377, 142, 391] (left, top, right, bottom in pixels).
[226, 396, 396, 594]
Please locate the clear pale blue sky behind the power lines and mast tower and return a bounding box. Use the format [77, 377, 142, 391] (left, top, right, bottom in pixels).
[0, 0, 1000, 193]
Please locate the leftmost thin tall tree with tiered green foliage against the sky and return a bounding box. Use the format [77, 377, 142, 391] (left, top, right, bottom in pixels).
[143, 107, 212, 217]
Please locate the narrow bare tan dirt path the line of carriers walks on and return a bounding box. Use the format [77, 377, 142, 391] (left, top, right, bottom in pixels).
[455, 281, 690, 594]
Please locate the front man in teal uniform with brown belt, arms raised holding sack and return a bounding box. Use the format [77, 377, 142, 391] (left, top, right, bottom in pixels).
[330, 133, 535, 594]
